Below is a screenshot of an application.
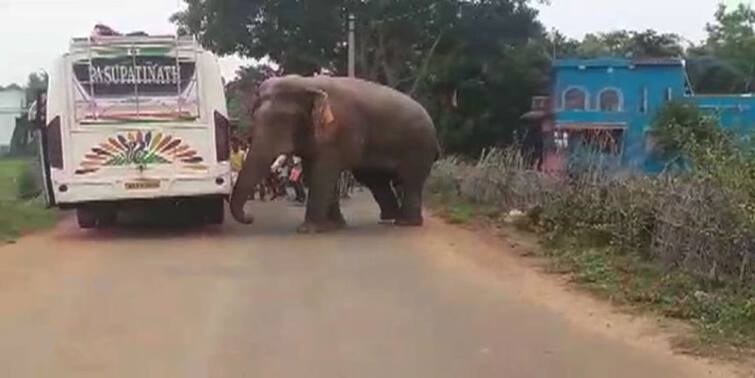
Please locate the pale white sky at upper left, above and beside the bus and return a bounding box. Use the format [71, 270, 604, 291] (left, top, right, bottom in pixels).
[0, 0, 248, 85]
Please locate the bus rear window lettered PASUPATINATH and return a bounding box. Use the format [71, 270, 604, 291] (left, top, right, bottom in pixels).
[73, 47, 199, 124]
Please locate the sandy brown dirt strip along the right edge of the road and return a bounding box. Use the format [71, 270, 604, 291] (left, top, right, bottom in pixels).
[430, 215, 755, 378]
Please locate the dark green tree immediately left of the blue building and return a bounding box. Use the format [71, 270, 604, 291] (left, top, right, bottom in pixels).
[424, 1, 549, 155]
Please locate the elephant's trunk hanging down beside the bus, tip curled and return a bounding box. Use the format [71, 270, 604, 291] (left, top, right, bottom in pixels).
[230, 148, 275, 224]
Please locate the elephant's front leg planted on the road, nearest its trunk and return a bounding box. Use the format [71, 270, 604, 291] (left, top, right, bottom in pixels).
[299, 160, 345, 233]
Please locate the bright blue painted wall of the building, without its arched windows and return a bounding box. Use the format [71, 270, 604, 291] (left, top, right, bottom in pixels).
[546, 59, 755, 172]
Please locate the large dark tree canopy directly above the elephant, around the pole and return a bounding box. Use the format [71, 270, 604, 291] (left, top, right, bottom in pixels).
[172, 0, 460, 89]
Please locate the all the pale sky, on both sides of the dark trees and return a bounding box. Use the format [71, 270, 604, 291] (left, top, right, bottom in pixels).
[0, 0, 750, 85]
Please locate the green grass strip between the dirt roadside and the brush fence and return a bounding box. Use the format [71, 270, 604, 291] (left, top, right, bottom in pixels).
[428, 192, 755, 355]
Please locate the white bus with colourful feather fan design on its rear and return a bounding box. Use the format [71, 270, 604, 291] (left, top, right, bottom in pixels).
[39, 36, 231, 228]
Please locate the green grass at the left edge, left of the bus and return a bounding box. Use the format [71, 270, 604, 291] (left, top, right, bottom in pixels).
[0, 159, 56, 243]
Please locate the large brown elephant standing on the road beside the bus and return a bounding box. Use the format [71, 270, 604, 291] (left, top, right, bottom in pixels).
[230, 75, 440, 233]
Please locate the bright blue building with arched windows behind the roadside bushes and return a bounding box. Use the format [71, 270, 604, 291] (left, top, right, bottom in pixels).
[526, 58, 755, 172]
